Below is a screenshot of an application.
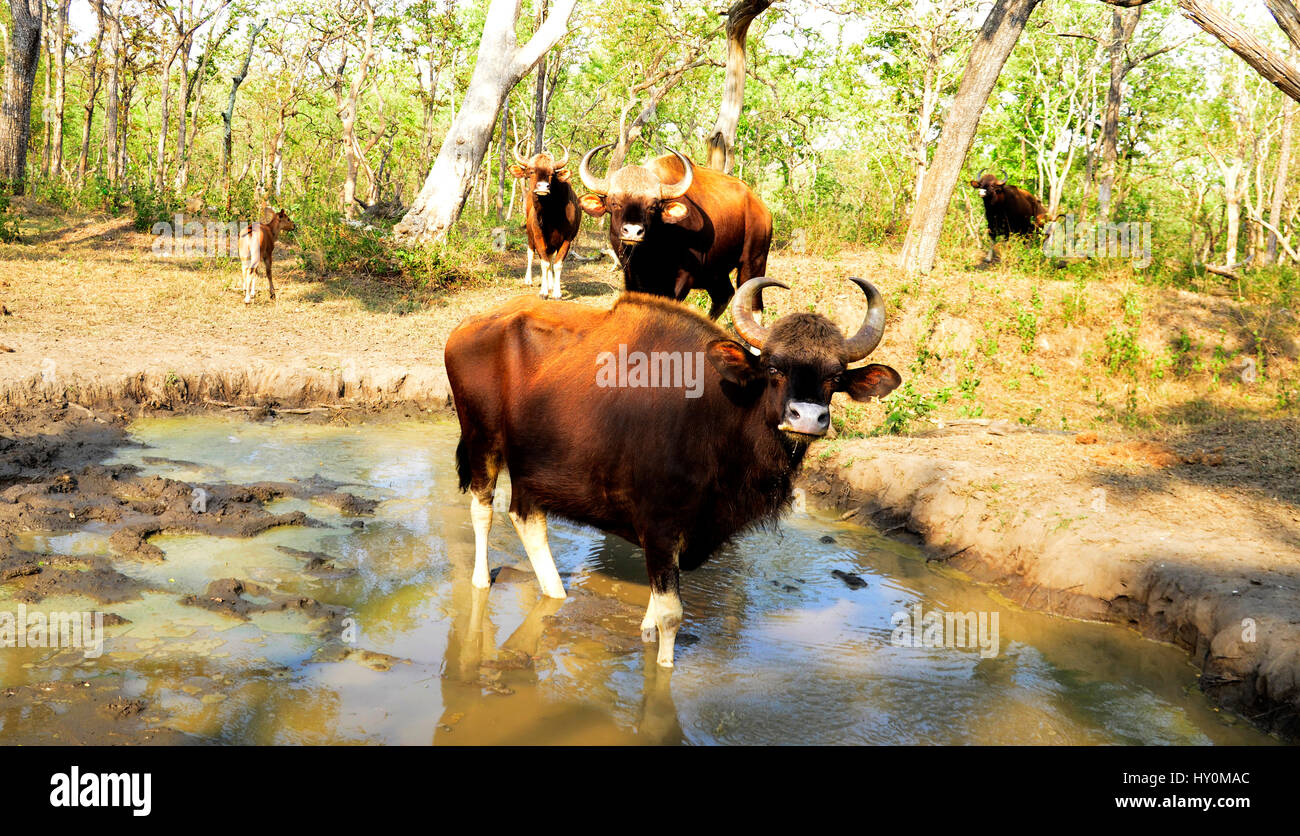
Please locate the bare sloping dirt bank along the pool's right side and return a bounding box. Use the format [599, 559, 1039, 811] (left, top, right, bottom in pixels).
[802, 423, 1300, 740]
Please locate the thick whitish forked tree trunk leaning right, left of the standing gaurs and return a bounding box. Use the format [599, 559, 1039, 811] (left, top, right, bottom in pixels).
[393, 0, 577, 243]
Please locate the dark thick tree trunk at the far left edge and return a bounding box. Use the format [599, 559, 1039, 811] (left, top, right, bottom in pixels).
[0, 0, 43, 195]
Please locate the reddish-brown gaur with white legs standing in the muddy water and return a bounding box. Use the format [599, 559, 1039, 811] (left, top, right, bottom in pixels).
[446, 280, 902, 667]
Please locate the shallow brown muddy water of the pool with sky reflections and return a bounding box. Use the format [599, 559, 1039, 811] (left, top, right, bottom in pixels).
[0, 416, 1270, 744]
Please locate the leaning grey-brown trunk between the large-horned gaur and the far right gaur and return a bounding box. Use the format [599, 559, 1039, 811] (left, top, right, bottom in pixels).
[898, 0, 1040, 273]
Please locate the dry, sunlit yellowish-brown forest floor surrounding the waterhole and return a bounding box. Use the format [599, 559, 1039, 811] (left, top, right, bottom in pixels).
[0, 202, 1300, 737]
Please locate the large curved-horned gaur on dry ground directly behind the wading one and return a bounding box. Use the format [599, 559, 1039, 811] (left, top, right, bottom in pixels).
[579, 143, 772, 319]
